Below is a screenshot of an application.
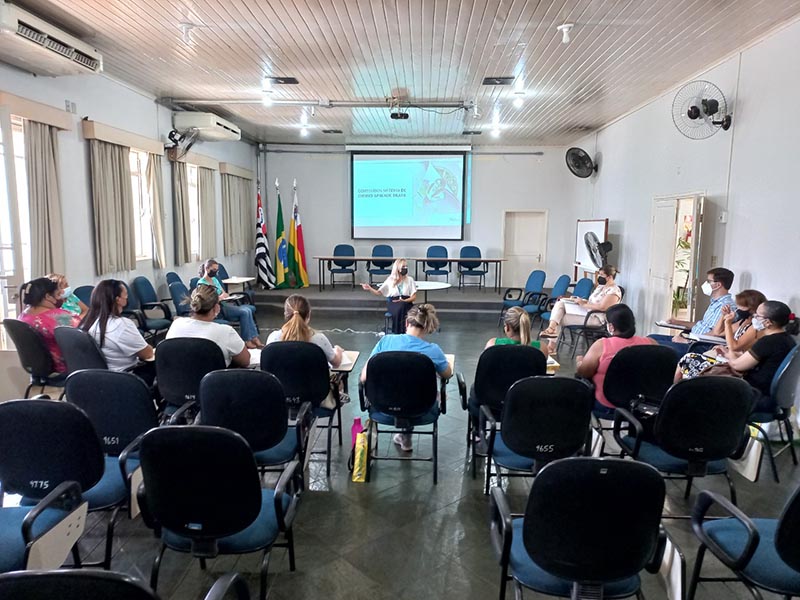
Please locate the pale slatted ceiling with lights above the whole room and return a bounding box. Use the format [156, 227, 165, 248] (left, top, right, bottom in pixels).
[10, 0, 800, 145]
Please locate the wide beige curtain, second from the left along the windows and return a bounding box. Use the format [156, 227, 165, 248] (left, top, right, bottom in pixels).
[89, 140, 136, 275]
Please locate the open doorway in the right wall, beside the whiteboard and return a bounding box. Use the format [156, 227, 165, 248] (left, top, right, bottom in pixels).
[646, 194, 705, 330]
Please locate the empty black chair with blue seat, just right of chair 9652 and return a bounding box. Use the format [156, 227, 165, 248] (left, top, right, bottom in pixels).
[200, 369, 311, 477]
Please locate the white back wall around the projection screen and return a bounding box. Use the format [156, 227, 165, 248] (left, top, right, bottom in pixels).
[266, 146, 578, 284]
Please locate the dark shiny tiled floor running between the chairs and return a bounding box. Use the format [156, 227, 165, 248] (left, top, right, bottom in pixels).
[69, 316, 800, 600]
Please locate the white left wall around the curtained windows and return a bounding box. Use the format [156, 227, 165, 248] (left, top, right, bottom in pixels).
[0, 65, 256, 294]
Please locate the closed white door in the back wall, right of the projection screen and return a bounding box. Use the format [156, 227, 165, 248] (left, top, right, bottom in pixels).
[503, 210, 547, 287]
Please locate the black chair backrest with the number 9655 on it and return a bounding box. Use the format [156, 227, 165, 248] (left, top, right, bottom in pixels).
[502, 375, 594, 463]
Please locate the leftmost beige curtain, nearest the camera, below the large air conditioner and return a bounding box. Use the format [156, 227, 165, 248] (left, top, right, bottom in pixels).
[24, 120, 64, 277]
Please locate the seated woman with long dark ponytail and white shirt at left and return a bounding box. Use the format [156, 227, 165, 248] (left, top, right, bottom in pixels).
[80, 279, 156, 386]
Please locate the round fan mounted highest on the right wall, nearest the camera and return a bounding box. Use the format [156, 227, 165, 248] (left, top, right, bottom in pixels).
[672, 80, 733, 140]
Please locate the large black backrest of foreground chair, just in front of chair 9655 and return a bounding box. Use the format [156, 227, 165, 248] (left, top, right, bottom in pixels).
[522, 457, 665, 583]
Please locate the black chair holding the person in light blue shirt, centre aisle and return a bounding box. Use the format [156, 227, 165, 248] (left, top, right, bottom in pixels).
[358, 351, 447, 485]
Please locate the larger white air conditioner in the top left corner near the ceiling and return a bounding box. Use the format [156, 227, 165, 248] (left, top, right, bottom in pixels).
[0, 0, 103, 77]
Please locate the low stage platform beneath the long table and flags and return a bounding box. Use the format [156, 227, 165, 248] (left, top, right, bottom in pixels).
[255, 284, 502, 322]
